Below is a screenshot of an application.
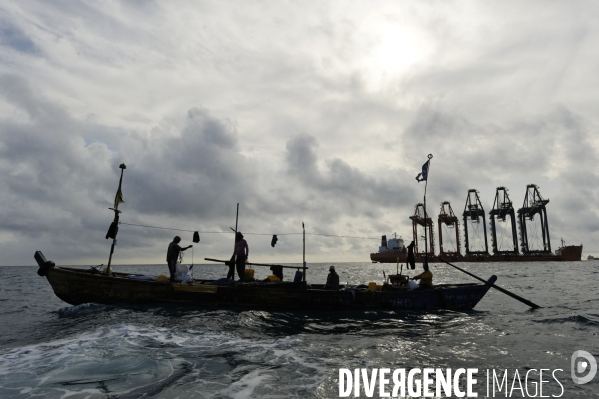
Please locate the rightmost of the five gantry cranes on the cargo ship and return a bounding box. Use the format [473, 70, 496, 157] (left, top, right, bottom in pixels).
[518, 184, 551, 254]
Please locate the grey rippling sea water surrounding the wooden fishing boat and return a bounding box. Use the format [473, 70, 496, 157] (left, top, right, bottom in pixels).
[0, 261, 599, 398]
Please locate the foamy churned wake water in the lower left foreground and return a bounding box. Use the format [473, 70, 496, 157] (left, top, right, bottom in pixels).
[0, 324, 328, 397]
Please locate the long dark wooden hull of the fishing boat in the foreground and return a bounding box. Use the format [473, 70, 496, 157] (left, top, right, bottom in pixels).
[35, 251, 497, 310]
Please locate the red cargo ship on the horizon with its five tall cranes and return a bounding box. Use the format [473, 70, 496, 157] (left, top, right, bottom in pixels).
[370, 184, 582, 263]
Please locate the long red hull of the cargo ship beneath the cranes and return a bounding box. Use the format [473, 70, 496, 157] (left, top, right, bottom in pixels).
[370, 245, 582, 263]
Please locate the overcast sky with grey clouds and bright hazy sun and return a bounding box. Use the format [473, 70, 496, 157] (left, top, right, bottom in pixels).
[0, 0, 599, 265]
